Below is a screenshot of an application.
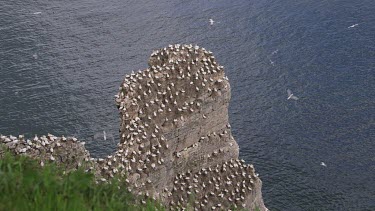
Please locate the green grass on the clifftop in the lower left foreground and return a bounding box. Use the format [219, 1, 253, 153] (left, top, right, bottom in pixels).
[0, 153, 164, 211]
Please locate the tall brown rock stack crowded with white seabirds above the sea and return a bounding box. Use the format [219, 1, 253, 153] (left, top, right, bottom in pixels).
[0, 45, 266, 210]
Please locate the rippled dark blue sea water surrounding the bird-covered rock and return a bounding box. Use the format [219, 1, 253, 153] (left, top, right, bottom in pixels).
[0, 0, 375, 210]
